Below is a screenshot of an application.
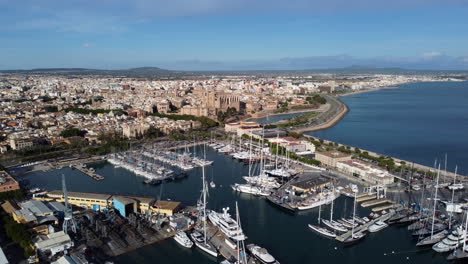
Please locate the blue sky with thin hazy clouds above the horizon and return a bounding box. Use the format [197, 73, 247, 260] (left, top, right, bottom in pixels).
[0, 0, 468, 70]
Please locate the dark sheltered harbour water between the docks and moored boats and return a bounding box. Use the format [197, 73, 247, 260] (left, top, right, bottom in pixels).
[23, 148, 446, 264]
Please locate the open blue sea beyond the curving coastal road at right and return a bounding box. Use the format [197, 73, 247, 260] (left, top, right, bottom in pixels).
[307, 82, 468, 175]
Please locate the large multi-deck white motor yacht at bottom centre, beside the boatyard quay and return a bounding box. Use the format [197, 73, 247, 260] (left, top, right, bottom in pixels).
[208, 207, 247, 241]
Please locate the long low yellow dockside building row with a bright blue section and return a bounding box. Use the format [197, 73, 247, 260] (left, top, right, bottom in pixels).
[34, 191, 180, 217]
